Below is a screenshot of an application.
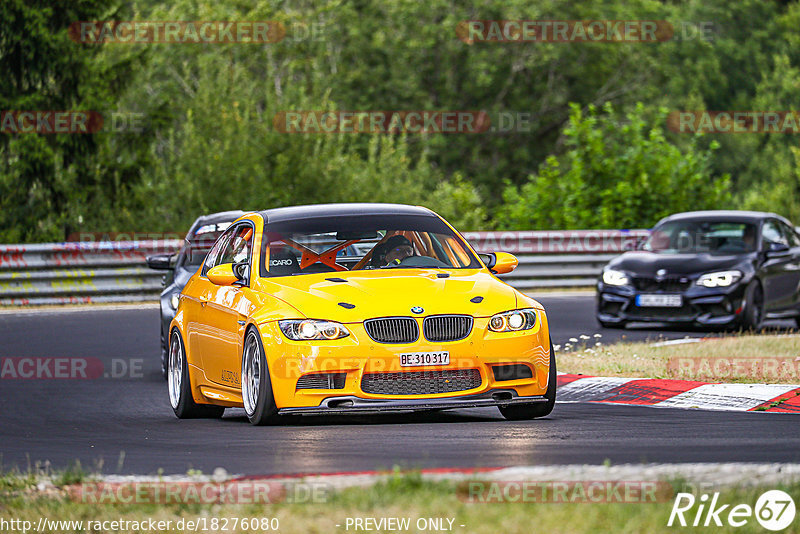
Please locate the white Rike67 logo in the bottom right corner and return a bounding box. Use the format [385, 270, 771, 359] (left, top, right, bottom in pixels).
[667, 490, 796, 531]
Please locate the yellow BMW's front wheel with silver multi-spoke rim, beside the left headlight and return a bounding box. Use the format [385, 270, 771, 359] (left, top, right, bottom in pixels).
[241, 328, 280, 426]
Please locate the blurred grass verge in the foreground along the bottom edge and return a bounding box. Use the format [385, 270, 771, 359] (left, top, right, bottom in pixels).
[0, 473, 800, 534]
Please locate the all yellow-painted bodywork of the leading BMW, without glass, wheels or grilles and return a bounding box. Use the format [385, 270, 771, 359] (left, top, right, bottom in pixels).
[170, 214, 550, 409]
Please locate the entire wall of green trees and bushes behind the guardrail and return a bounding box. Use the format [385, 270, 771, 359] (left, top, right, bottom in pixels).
[0, 0, 800, 242]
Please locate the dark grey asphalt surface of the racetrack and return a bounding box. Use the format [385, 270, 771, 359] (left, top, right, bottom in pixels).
[0, 294, 800, 474]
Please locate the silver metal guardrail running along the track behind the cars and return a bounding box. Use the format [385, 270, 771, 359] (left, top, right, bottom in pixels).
[0, 230, 647, 306]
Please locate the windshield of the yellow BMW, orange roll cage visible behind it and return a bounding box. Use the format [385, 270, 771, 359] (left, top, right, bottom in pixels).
[260, 215, 482, 277]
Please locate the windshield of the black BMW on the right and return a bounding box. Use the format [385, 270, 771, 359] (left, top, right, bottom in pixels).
[642, 220, 756, 254]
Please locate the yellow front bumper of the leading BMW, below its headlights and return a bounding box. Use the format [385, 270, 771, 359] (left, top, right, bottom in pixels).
[261, 313, 550, 414]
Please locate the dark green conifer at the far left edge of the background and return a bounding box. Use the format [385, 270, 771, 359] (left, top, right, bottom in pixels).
[0, 0, 141, 242]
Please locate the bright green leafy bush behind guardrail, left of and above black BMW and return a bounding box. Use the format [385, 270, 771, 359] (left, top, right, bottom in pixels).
[500, 104, 729, 229]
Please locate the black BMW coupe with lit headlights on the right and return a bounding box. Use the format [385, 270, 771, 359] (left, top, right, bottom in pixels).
[597, 211, 800, 329]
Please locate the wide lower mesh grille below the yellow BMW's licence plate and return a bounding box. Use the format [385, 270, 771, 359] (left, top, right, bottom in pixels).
[361, 369, 481, 395]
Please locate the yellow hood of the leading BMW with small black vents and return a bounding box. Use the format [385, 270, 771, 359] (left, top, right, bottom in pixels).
[254, 269, 517, 323]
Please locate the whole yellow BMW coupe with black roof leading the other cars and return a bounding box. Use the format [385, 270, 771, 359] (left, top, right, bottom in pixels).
[167, 204, 556, 425]
